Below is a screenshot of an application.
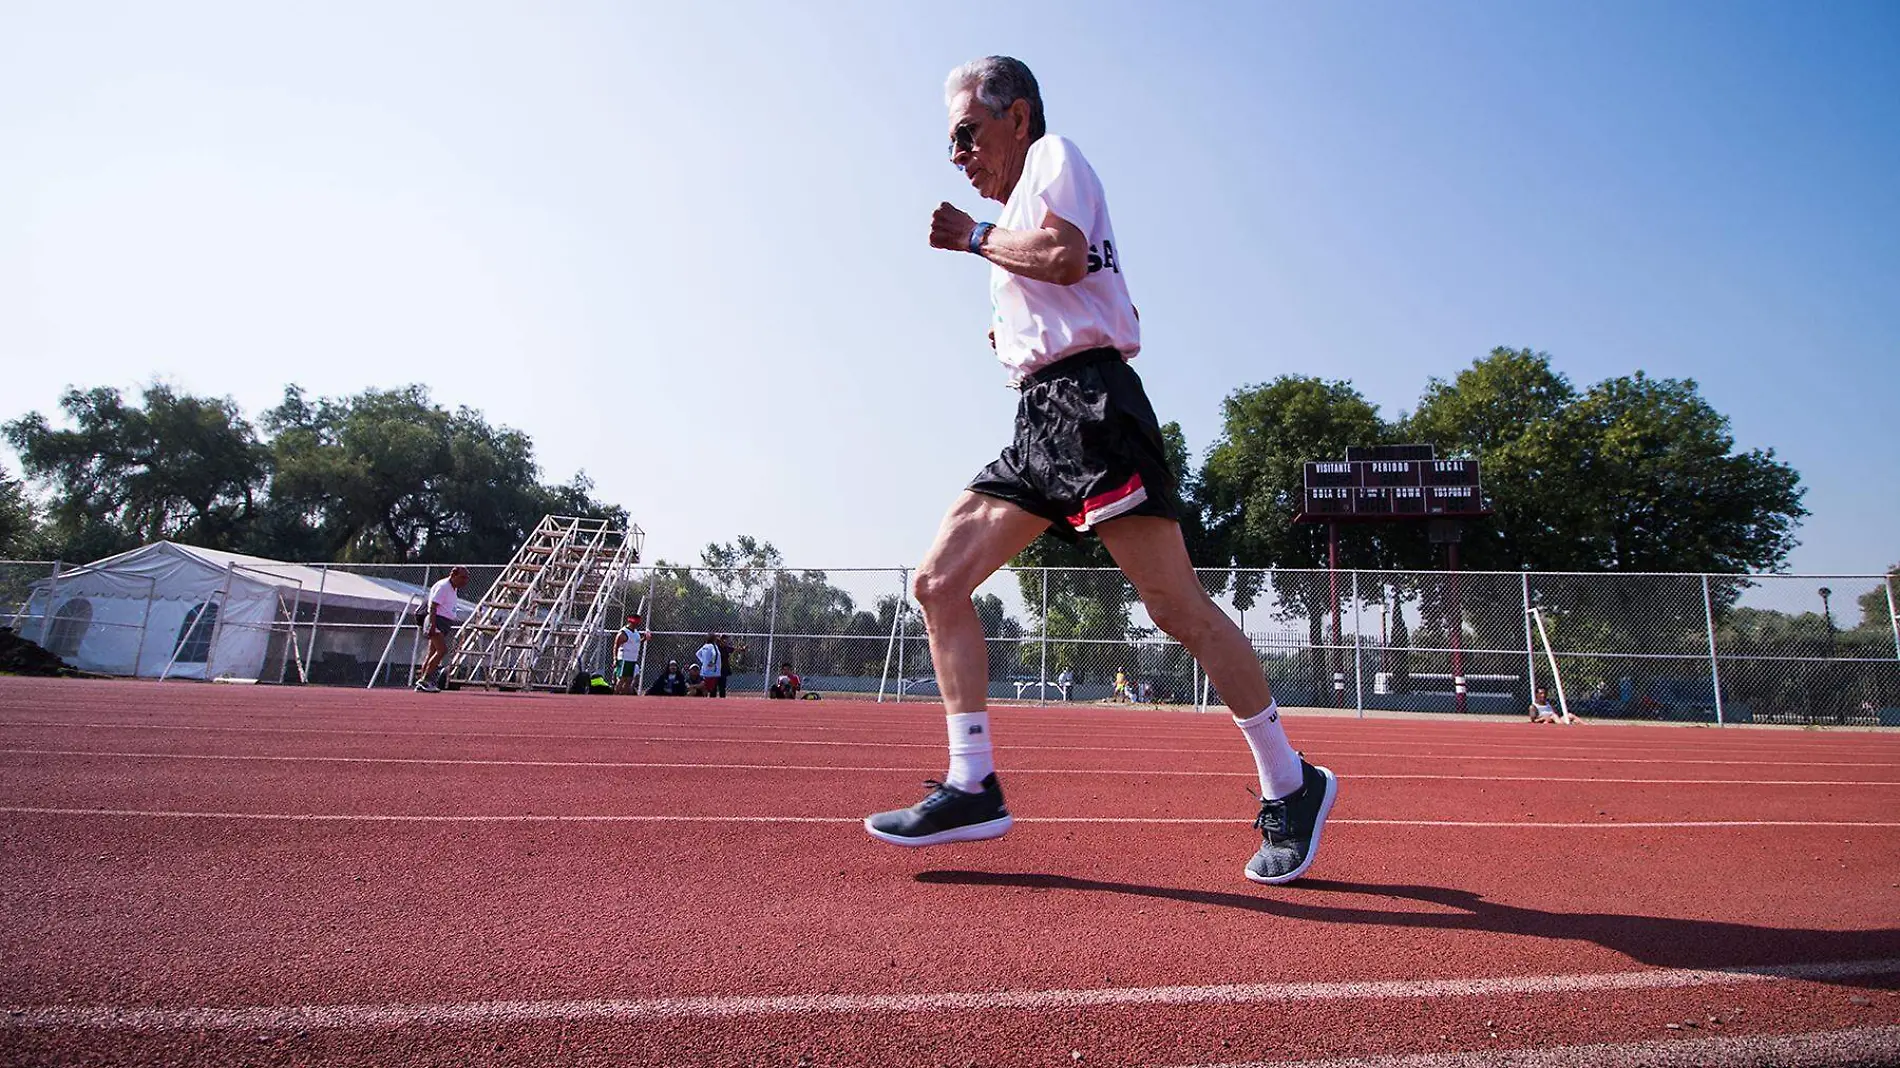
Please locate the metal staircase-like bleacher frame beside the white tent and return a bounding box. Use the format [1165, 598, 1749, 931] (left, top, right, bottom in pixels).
[448, 515, 642, 690]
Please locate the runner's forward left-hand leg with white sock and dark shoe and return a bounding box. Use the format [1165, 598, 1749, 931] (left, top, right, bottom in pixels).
[865, 490, 1049, 846]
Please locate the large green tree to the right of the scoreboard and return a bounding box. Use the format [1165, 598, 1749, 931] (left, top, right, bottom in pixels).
[1397, 348, 1807, 706]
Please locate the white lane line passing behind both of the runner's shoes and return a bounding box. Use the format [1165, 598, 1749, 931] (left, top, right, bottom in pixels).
[0, 806, 1900, 830]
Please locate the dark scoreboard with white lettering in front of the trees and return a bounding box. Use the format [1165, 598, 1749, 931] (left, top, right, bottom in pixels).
[1303, 445, 1488, 519]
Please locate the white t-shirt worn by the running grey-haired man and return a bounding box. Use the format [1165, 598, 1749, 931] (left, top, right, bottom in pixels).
[990, 133, 1142, 382]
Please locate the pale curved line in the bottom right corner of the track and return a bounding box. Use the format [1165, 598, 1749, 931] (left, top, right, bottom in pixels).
[1170, 1026, 1900, 1068]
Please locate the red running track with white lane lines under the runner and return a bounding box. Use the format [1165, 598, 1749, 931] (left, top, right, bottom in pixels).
[0, 678, 1900, 1066]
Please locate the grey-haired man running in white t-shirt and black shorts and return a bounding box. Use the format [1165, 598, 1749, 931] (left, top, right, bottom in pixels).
[865, 55, 1338, 884]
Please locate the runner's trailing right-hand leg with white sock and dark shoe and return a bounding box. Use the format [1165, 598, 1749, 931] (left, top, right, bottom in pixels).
[1096, 515, 1338, 884]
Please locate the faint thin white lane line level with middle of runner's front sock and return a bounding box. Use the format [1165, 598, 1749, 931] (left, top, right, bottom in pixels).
[0, 722, 1900, 770]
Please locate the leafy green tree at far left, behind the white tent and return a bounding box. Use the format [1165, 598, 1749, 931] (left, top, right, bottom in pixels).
[4, 386, 270, 559]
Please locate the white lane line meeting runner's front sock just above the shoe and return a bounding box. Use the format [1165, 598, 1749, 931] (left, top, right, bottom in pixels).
[0, 749, 1900, 787]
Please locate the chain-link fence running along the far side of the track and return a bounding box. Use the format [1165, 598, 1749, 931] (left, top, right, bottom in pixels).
[0, 561, 1900, 726]
